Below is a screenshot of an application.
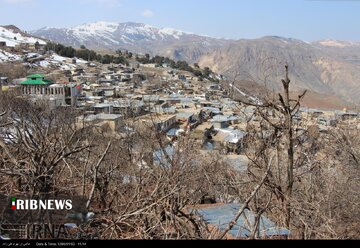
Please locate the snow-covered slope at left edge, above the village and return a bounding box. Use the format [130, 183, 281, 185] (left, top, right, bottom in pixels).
[0, 26, 46, 47]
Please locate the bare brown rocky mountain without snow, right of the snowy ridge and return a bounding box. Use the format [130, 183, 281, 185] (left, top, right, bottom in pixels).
[199, 37, 360, 103]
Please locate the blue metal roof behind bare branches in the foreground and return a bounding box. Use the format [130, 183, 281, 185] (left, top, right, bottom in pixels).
[197, 203, 290, 238]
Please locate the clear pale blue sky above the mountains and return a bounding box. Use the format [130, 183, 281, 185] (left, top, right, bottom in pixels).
[0, 0, 360, 41]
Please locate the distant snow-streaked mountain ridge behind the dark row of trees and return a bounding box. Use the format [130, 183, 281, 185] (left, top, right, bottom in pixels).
[31, 21, 228, 61]
